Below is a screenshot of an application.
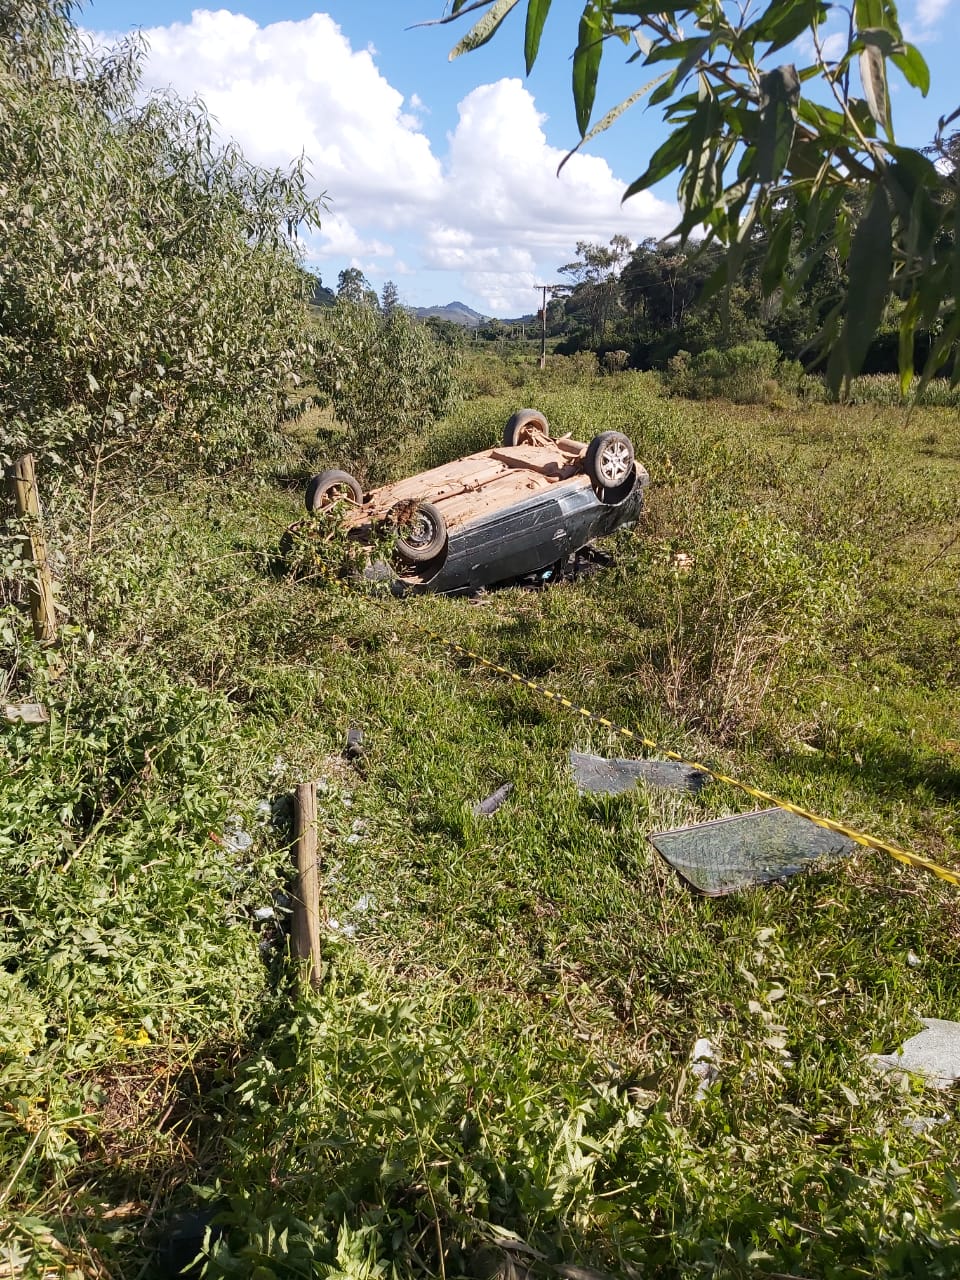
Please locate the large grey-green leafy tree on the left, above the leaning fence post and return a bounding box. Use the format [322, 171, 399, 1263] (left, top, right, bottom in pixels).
[0, 0, 321, 472]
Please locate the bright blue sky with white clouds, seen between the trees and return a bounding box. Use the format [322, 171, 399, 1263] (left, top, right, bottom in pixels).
[79, 0, 960, 316]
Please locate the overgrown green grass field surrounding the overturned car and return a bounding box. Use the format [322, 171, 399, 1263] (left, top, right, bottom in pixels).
[0, 374, 960, 1280]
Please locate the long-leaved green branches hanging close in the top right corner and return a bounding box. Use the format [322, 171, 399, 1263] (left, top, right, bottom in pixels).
[436, 0, 960, 390]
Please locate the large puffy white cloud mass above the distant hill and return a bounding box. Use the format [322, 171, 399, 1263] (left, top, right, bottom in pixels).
[99, 10, 675, 314]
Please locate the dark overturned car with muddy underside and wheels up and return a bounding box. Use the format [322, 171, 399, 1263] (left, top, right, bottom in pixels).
[306, 408, 649, 593]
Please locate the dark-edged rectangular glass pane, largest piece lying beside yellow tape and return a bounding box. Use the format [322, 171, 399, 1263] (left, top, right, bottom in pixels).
[648, 809, 856, 896]
